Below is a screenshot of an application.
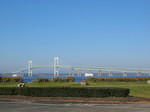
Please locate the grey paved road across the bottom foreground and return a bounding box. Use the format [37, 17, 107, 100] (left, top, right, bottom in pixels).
[0, 101, 150, 112]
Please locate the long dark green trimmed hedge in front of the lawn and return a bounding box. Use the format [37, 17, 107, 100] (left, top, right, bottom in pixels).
[0, 87, 129, 97]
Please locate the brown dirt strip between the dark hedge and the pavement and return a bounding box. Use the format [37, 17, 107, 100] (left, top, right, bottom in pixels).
[0, 95, 150, 104]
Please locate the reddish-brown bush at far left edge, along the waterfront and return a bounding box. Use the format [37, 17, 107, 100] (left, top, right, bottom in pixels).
[0, 77, 23, 82]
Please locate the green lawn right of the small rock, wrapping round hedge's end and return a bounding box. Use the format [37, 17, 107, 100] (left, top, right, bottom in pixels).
[86, 81, 150, 98]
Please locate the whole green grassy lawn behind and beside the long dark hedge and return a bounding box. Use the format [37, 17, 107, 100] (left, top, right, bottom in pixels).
[0, 81, 150, 98]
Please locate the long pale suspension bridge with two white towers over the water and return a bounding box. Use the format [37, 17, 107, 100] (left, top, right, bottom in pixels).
[15, 57, 150, 77]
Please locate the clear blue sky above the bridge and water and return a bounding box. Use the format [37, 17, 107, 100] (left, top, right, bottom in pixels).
[0, 0, 150, 72]
